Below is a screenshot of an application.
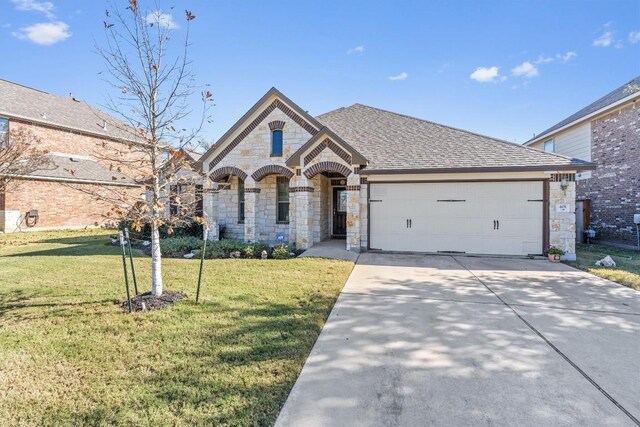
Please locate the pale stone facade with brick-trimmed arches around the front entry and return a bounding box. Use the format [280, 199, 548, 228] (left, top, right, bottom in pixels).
[204, 97, 366, 251]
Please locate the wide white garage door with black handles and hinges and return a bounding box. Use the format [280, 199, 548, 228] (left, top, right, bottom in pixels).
[370, 181, 543, 255]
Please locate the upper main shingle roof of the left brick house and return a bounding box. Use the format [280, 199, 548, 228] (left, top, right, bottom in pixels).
[0, 79, 140, 141]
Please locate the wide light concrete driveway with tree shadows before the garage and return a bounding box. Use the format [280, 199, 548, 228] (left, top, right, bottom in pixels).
[276, 253, 640, 427]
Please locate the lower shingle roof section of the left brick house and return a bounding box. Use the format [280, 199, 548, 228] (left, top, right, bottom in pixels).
[29, 153, 135, 185]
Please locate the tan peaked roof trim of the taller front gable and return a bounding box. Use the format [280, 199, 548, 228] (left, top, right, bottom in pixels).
[198, 87, 322, 169]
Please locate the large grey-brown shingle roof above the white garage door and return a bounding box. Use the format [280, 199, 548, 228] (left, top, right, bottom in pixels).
[317, 104, 592, 173]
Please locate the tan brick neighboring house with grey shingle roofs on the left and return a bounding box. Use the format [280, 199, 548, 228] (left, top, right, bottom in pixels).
[0, 80, 141, 232]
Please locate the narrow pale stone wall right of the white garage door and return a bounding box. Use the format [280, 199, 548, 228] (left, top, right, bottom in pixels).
[549, 181, 576, 261]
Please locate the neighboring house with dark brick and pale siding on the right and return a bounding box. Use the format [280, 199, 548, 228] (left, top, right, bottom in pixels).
[525, 77, 640, 246]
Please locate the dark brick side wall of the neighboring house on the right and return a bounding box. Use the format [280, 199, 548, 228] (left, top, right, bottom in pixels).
[577, 104, 640, 245]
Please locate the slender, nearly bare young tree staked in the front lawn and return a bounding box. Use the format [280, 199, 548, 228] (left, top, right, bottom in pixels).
[85, 0, 212, 296]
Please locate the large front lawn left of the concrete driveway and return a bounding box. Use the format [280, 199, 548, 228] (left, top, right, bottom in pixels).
[0, 231, 353, 426]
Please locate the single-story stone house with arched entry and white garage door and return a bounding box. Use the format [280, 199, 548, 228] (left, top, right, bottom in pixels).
[199, 88, 593, 259]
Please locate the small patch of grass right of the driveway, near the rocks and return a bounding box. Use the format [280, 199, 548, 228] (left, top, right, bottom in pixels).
[567, 245, 640, 290]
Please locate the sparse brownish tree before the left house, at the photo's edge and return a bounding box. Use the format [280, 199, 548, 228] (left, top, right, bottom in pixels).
[0, 129, 51, 193]
